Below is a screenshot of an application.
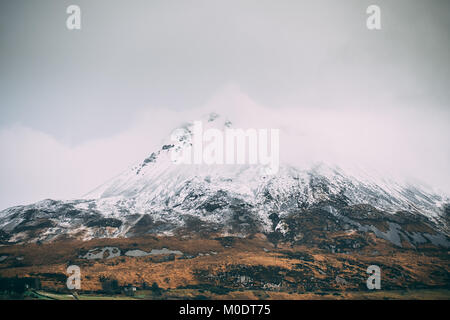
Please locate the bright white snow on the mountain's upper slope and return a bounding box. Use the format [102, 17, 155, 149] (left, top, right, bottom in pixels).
[82, 112, 444, 217]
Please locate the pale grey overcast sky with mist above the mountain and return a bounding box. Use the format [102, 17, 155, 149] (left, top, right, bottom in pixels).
[0, 0, 450, 210]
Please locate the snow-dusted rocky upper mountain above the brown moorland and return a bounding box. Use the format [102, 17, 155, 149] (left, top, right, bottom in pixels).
[0, 114, 450, 247]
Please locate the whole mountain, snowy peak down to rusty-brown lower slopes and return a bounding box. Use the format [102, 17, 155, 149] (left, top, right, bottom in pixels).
[0, 114, 450, 299]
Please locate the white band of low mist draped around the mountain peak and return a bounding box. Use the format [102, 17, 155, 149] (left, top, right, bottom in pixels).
[0, 85, 450, 208]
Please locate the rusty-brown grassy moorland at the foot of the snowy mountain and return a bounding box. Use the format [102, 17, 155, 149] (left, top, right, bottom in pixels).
[0, 234, 450, 300]
